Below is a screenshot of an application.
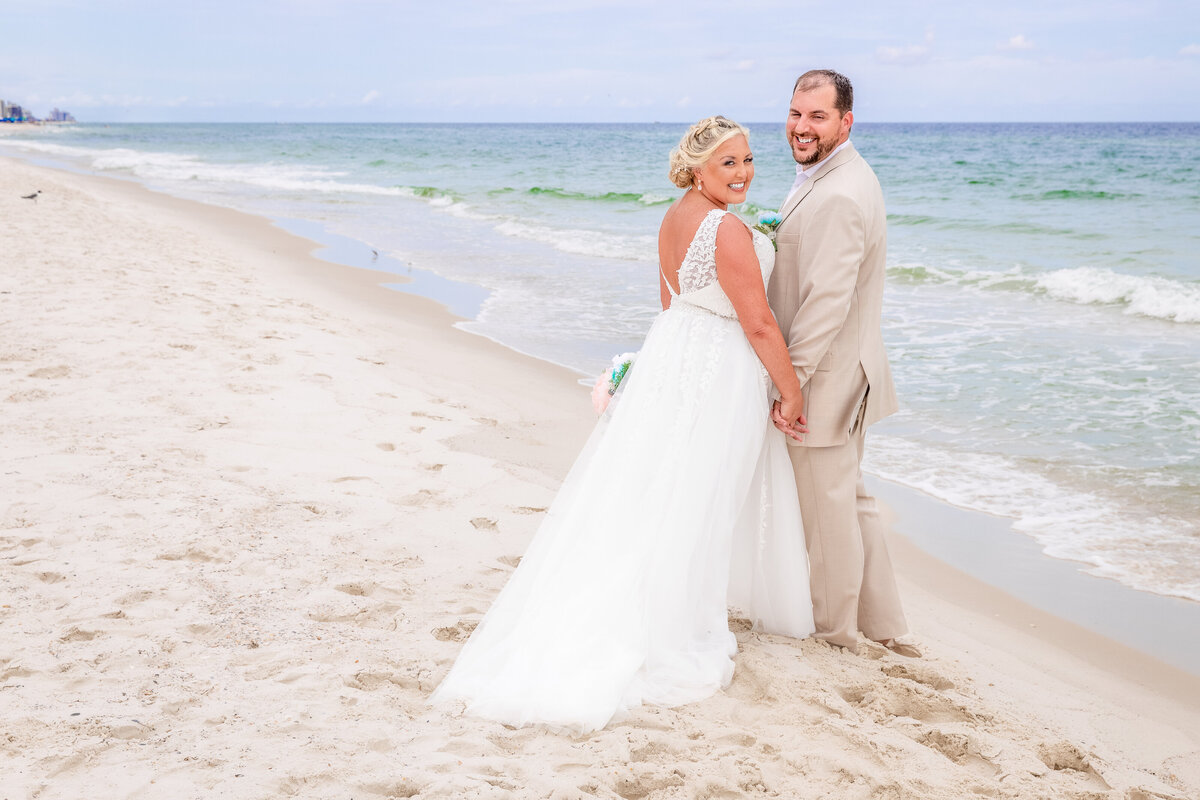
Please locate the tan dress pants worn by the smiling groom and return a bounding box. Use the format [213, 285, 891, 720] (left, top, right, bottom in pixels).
[787, 421, 908, 652]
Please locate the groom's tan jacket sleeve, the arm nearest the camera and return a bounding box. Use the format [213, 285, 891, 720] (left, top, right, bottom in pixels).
[787, 194, 866, 385]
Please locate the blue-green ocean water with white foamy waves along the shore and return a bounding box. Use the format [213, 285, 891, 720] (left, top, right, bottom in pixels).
[0, 122, 1200, 600]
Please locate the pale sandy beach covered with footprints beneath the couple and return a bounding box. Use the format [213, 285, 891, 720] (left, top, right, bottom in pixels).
[0, 153, 1200, 800]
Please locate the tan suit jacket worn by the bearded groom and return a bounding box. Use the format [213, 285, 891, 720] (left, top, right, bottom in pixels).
[767, 144, 896, 447]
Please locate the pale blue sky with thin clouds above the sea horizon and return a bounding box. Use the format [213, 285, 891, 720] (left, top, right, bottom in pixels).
[0, 0, 1200, 122]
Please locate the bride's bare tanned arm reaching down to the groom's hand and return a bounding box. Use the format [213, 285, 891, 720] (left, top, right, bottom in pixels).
[716, 215, 804, 434]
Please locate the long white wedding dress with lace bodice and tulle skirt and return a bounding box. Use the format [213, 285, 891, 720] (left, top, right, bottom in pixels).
[431, 209, 814, 733]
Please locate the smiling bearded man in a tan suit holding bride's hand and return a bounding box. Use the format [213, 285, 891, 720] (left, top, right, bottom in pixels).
[767, 70, 920, 657]
